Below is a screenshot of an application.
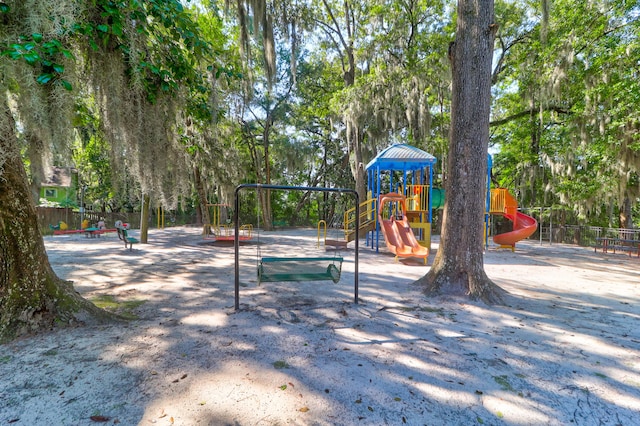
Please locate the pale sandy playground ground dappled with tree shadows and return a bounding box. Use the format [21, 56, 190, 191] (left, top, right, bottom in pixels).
[0, 228, 640, 425]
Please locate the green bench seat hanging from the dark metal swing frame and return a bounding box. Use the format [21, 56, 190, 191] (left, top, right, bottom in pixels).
[258, 257, 343, 284]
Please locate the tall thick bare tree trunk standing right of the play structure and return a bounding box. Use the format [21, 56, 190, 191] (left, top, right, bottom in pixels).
[417, 0, 504, 303]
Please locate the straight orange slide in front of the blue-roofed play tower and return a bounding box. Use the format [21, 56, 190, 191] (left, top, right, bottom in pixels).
[378, 192, 429, 264]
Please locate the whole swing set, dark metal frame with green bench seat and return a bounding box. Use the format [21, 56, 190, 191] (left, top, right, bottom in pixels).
[233, 184, 360, 310]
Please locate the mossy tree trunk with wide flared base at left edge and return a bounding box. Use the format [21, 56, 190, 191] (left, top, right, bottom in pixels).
[0, 101, 108, 342]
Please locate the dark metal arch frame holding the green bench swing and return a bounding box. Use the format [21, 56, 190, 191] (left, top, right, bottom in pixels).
[233, 183, 360, 311]
